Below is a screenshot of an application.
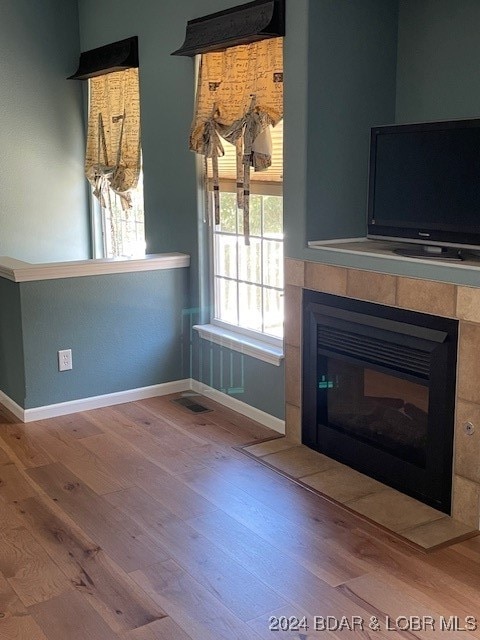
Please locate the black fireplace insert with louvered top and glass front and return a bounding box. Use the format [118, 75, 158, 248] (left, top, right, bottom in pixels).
[302, 291, 458, 513]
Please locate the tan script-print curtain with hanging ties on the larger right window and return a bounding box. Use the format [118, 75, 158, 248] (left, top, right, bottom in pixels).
[190, 38, 283, 243]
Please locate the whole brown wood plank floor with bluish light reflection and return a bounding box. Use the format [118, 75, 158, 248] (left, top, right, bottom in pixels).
[0, 398, 480, 640]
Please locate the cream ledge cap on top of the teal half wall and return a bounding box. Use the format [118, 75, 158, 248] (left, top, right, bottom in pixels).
[0, 253, 190, 282]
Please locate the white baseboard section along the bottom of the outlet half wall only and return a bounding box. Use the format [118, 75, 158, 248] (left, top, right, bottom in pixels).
[21, 378, 191, 422]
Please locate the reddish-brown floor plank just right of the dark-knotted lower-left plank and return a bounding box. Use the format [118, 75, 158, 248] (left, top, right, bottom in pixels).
[29, 463, 168, 573]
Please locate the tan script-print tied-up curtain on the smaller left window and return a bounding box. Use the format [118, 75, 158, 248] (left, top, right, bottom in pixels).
[85, 68, 141, 209]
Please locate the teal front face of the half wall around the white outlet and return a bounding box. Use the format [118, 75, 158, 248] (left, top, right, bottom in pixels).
[20, 269, 188, 409]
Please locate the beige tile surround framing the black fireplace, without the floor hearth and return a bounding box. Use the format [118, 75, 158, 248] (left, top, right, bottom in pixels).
[285, 258, 480, 530]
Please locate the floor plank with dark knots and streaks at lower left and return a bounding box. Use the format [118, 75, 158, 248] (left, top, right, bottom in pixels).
[17, 498, 165, 632]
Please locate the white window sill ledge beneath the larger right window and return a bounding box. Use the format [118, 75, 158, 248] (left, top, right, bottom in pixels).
[193, 324, 284, 367]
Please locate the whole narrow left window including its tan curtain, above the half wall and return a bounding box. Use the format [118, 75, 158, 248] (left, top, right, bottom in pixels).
[85, 68, 145, 258]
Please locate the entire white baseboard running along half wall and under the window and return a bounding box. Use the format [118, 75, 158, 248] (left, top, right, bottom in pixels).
[0, 378, 285, 434]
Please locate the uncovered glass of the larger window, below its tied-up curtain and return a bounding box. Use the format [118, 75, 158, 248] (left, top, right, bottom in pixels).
[211, 122, 283, 340]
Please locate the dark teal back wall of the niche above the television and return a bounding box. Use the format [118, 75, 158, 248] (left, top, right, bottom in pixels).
[396, 0, 480, 122]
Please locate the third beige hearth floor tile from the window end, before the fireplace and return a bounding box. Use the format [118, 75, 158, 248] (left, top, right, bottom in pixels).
[300, 462, 385, 502]
